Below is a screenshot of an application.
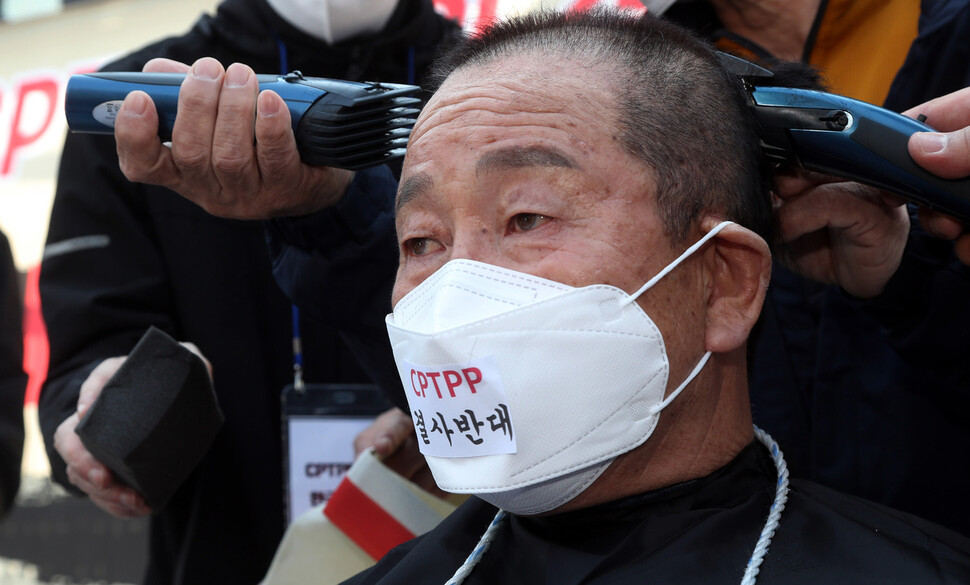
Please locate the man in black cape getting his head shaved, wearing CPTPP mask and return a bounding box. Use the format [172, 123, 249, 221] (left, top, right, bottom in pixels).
[328, 14, 970, 585]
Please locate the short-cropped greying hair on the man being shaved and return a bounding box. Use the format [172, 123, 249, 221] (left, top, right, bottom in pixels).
[433, 10, 771, 244]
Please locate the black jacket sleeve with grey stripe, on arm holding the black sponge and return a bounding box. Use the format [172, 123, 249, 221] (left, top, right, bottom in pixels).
[38, 134, 178, 487]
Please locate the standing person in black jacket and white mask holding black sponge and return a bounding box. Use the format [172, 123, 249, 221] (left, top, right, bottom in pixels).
[38, 0, 458, 585]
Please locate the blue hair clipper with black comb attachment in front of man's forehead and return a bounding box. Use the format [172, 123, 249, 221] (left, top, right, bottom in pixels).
[64, 71, 421, 170]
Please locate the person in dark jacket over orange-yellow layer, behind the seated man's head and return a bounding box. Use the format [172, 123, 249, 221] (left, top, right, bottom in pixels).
[664, 0, 970, 534]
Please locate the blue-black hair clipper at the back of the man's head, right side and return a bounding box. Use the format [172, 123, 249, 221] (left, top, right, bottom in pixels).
[719, 53, 970, 222]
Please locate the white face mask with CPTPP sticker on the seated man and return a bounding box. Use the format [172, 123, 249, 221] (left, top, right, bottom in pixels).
[386, 222, 730, 514]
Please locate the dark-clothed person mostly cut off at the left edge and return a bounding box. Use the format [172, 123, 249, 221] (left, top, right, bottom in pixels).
[0, 233, 27, 516]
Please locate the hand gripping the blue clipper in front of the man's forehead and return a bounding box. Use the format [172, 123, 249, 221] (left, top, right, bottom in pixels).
[69, 57, 416, 220]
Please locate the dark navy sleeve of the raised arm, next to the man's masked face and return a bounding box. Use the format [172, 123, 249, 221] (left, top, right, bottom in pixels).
[267, 167, 406, 408]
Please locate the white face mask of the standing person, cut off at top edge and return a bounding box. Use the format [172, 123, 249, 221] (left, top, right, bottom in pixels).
[267, 0, 398, 45]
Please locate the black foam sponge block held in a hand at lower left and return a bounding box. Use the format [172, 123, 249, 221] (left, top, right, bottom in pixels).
[76, 327, 223, 512]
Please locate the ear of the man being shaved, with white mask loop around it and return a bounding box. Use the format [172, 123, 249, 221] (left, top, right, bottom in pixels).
[705, 219, 771, 353]
